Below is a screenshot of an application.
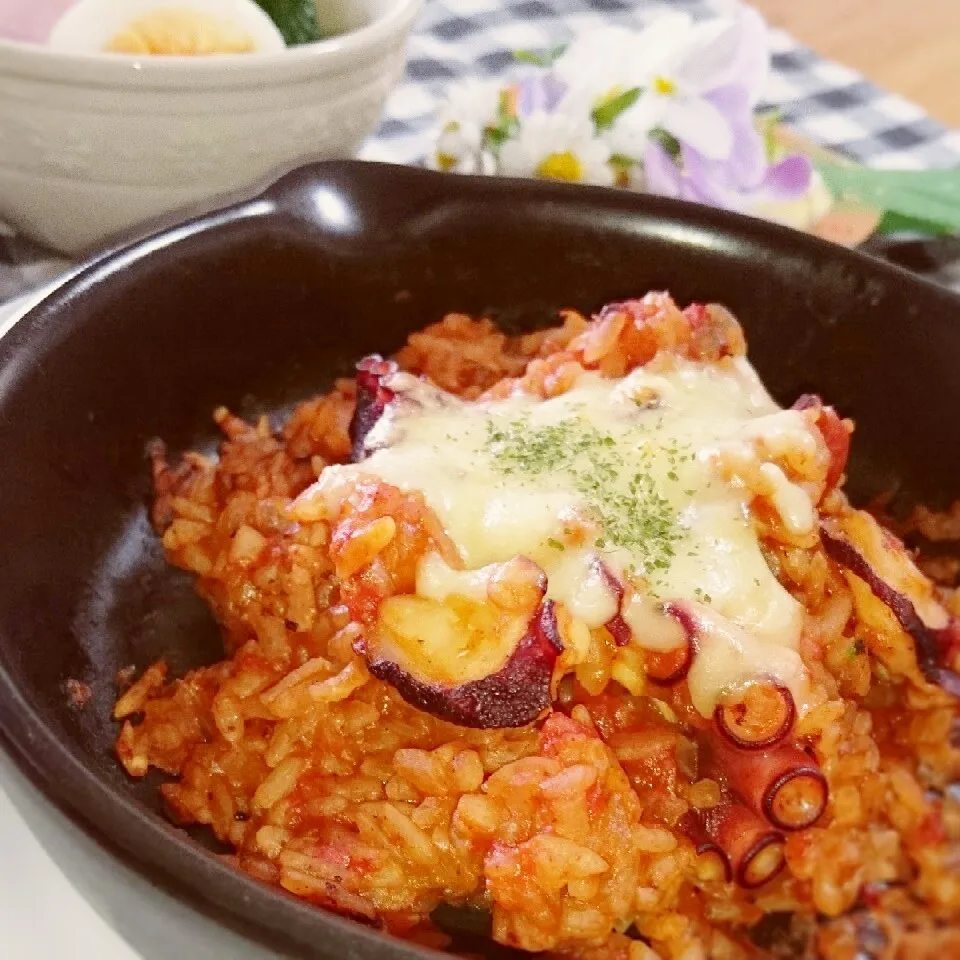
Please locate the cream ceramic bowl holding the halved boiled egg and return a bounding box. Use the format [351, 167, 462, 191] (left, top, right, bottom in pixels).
[0, 0, 423, 254]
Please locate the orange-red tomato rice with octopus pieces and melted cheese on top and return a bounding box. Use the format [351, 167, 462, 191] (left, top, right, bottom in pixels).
[115, 293, 960, 960]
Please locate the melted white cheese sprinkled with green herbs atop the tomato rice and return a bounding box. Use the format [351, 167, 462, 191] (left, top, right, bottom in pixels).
[305, 358, 817, 713]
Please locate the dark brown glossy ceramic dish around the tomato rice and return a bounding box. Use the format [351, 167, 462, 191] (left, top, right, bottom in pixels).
[0, 163, 960, 960]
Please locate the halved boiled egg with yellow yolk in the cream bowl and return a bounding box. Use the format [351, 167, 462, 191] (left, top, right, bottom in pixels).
[48, 0, 286, 57]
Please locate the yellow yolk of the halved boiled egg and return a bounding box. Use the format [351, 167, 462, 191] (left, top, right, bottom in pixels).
[104, 10, 255, 57]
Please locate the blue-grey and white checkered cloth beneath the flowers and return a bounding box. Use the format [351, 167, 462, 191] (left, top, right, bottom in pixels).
[0, 0, 960, 301]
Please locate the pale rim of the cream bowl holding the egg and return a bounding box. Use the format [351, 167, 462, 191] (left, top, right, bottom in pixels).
[0, 0, 426, 90]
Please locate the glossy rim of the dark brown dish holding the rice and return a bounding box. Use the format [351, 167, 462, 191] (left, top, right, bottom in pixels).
[0, 161, 960, 960]
